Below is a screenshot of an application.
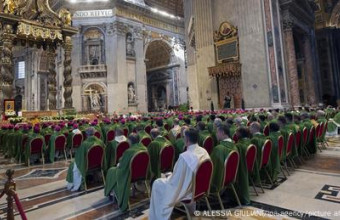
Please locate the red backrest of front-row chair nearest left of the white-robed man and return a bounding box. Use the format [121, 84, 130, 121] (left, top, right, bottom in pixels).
[130, 151, 150, 183]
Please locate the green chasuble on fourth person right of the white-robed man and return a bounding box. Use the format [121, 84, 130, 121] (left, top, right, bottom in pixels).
[268, 132, 281, 182]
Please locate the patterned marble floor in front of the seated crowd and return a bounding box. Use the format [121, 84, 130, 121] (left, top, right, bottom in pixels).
[0, 137, 340, 220]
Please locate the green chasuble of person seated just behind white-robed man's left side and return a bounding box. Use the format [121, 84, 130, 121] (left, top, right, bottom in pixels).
[148, 136, 171, 179]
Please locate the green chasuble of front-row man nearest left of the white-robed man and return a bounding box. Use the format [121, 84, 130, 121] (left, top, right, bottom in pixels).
[104, 144, 147, 211]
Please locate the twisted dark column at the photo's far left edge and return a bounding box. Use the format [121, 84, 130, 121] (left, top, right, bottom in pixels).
[0, 24, 15, 102]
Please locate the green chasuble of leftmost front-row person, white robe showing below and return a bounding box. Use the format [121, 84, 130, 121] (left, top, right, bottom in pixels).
[66, 136, 107, 185]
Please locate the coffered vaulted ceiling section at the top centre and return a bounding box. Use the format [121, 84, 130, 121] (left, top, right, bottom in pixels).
[144, 0, 184, 17]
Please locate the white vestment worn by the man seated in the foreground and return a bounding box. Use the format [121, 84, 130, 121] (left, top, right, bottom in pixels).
[149, 144, 210, 220]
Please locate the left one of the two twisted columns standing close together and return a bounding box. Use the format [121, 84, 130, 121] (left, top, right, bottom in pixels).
[48, 47, 57, 110]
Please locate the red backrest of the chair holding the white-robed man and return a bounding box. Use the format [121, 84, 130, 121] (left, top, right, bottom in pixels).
[192, 159, 213, 201]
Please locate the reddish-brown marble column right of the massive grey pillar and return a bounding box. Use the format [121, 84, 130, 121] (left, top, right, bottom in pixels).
[283, 19, 300, 107]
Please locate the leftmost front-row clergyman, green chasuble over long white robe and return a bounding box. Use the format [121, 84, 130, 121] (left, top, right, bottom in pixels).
[66, 127, 106, 191]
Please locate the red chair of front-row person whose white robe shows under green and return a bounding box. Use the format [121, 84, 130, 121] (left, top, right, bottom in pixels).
[83, 145, 105, 191]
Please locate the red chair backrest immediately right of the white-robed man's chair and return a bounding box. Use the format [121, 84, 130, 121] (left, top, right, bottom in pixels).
[223, 150, 240, 187]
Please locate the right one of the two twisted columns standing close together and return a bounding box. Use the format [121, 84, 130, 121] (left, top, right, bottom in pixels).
[63, 36, 73, 109]
